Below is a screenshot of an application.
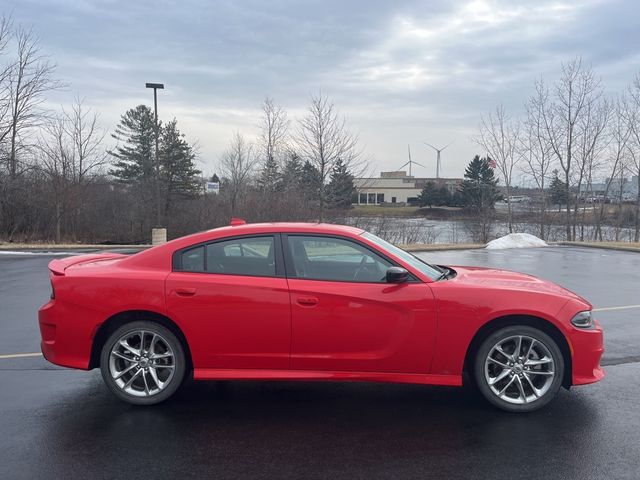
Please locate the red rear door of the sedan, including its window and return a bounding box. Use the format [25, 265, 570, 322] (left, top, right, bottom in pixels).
[166, 235, 291, 369]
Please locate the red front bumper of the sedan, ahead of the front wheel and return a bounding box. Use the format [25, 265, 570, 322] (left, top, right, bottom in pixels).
[570, 322, 604, 385]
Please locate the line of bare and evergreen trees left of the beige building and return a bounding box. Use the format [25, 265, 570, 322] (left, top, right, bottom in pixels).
[0, 16, 366, 243]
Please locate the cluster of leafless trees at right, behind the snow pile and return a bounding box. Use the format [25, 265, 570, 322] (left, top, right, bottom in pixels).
[475, 58, 640, 242]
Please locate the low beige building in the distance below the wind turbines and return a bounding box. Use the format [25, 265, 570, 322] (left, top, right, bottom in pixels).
[353, 171, 462, 205]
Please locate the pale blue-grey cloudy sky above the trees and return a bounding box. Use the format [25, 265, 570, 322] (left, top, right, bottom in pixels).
[5, 0, 640, 176]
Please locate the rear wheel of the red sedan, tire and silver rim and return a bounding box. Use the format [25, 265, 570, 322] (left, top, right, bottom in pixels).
[100, 321, 186, 405]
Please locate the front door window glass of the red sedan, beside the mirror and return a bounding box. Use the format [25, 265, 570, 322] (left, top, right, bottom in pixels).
[288, 235, 392, 283]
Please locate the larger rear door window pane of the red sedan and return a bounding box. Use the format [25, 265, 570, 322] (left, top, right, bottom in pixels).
[206, 236, 276, 277]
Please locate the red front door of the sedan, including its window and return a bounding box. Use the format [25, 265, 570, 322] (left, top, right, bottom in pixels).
[283, 234, 435, 373]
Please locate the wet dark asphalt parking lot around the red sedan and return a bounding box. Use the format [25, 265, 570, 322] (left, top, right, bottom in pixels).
[0, 247, 640, 479]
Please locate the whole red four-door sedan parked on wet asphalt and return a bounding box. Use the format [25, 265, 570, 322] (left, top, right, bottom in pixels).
[39, 222, 604, 412]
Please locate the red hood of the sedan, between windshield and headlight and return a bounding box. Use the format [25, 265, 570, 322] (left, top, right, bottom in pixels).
[450, 267, 591, 306]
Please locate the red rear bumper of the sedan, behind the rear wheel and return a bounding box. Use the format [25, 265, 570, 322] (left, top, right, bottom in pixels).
[38, 300, 93, 370]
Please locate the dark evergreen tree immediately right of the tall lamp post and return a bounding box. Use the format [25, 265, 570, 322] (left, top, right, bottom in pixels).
[158, 119, 202, 214]
